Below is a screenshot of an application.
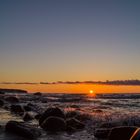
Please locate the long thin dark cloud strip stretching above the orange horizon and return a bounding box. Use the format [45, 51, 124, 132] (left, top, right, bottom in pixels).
[0, 80, 140, 86]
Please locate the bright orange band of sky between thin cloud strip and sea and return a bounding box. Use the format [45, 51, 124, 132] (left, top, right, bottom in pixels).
[0, 84, 140, 94]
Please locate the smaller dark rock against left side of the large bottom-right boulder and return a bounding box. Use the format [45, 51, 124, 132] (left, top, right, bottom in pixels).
[94, 129, 110, 139]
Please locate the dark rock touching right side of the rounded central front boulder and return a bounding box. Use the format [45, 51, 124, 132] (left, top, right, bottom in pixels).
[66, 118, 85, 129]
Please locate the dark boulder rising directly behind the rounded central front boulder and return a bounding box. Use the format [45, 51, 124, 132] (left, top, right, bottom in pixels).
[39, 107, 65, 125]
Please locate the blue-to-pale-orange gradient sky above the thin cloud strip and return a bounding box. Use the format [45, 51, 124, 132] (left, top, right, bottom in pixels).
[0, 0, 140, 92]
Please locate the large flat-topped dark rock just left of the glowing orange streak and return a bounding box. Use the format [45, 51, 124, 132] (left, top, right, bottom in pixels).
[109, 126, 137, 140]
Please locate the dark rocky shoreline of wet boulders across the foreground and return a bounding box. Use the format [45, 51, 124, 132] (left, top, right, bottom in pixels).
[0, 93, 140, 140]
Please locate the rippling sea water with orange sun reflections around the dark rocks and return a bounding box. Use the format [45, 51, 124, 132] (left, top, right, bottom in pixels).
[0, 94, 140, 140]
